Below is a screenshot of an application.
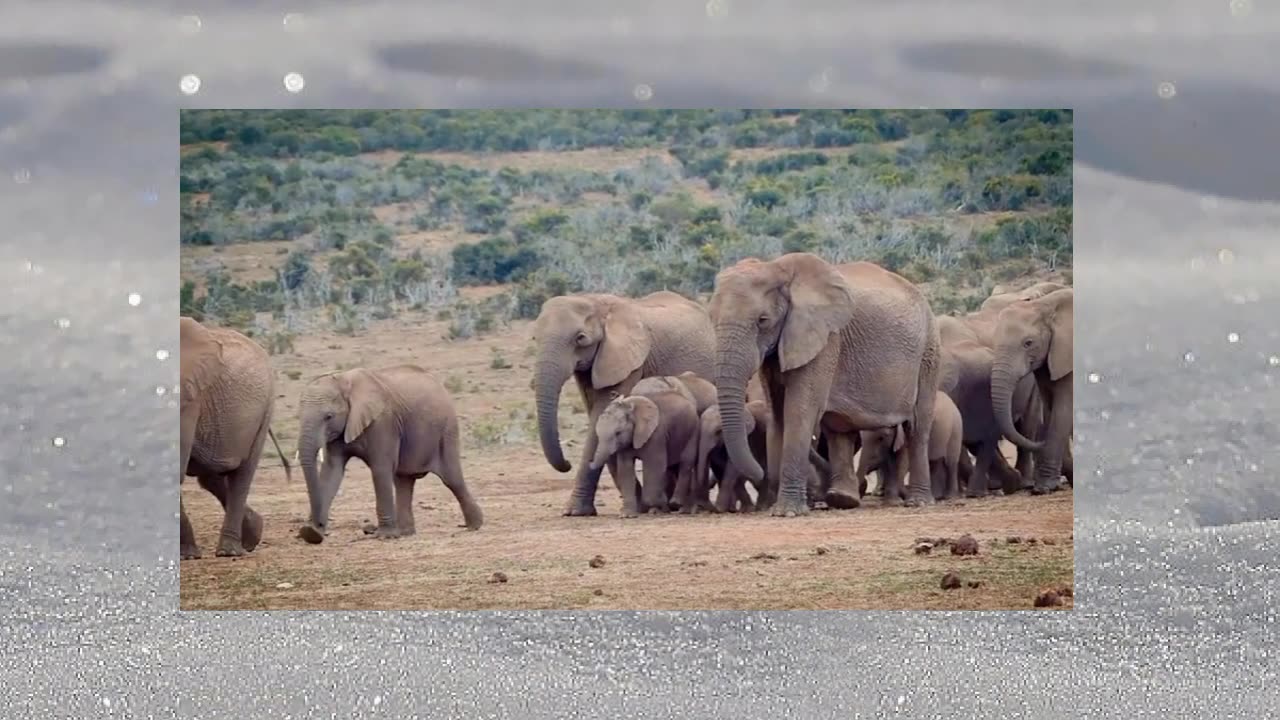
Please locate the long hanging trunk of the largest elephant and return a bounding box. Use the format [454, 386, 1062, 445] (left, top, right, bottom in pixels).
[716, 325, 764, 483]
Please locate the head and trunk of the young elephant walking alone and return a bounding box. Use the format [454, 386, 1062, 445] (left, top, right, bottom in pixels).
[298, 370, 388, 530]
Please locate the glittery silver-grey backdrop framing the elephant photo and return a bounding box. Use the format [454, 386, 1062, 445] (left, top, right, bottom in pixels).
[0, 0, 1280, 719]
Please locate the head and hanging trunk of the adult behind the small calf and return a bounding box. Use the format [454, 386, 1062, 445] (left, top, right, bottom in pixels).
[534, 295, 650, 473]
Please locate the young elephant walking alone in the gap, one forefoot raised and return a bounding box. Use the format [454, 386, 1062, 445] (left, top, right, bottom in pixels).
[298, 365, 484, 543]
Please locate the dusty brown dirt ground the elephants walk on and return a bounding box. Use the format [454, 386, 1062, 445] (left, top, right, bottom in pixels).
[180, 314, 1074, 610]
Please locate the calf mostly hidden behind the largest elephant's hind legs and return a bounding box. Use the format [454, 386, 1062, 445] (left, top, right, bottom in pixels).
[858, 391, 964, 500]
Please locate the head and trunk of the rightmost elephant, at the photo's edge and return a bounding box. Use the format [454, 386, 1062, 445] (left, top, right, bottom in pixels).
[991, 288, 1075, 450]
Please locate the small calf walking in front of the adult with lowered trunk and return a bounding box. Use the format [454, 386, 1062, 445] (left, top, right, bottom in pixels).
[591, 392, 698, 518]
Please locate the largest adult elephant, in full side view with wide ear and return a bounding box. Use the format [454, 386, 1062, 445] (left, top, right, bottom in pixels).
[710, 252, 941, 516]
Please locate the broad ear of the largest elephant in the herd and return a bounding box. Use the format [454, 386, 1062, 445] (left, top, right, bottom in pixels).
[777, 252, 854, 373]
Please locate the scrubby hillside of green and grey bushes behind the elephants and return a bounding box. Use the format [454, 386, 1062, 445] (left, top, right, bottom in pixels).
[180, 110, 1073, 346]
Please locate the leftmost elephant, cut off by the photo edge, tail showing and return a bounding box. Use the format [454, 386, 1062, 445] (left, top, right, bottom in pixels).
[178, 318, 289, 560]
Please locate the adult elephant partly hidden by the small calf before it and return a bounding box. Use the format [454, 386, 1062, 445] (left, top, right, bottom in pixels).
[534, 291, 716, 515]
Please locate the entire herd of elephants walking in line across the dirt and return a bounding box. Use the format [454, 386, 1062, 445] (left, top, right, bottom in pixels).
[179, 252, 1074, 559]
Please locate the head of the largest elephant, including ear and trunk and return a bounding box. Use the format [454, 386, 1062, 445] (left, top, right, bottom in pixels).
[709, 252, 854, 482]
